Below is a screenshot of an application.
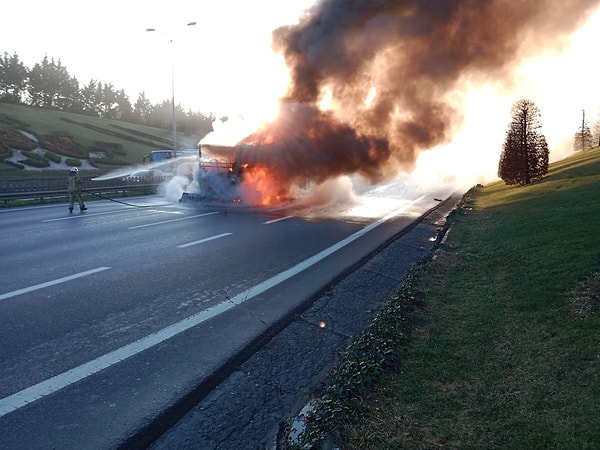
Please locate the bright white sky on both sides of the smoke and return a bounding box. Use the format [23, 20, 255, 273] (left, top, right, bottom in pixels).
[0, 0, 600, 186]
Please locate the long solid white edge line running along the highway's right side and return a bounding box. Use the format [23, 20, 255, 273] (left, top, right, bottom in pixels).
[0, 196, 425, 417]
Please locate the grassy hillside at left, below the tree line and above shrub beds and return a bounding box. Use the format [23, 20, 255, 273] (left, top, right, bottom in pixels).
[0, 103, 198, 176]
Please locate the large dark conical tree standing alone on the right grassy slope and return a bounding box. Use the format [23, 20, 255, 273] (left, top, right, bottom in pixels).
[498, 100, 549, 185]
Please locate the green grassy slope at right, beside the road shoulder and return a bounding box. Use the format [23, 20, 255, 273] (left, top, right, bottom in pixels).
[343, 149, 600, 449]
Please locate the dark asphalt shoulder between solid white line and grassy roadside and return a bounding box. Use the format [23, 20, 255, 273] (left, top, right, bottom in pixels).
[0, 194, 452, 448]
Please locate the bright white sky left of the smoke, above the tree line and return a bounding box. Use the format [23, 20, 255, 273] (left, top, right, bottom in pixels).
[0, 0, 314, 114]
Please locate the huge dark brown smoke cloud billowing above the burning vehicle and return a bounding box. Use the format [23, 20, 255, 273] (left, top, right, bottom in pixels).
[230, 0, 599, 195]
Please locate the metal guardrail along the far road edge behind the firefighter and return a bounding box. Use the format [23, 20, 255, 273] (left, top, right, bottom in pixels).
[0, 176, 171, 202]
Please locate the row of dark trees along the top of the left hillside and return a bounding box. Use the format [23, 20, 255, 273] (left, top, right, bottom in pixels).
[0, 52, 215, 135]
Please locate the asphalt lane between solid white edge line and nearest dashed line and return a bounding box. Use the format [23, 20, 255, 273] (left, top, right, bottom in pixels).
[0, 207, 366, 395]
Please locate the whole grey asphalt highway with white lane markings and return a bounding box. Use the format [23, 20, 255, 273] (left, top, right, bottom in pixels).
[0, 181, 449, 449]
